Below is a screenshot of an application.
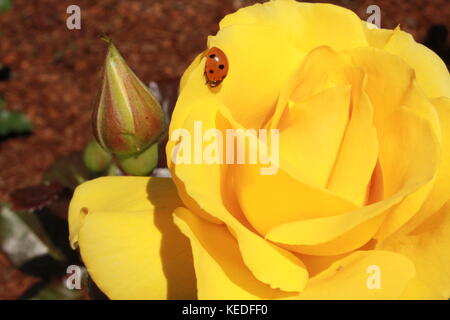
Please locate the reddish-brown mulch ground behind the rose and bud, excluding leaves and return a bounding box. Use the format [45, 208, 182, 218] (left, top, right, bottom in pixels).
[0, 0, 450, 299]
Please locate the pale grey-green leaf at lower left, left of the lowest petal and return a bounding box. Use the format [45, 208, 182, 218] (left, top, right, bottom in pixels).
[0, 206, 65, 267]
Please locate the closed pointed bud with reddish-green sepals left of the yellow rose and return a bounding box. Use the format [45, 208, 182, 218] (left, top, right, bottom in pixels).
[92, 39, 165, 156]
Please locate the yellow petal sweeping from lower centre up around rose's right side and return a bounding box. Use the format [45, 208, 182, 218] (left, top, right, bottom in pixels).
[266, 108, 439, 254]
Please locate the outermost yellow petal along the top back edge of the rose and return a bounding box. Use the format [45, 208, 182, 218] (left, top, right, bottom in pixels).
[220, 0, 367, 53]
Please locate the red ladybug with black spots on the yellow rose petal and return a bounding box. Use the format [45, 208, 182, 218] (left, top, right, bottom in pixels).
[205, 47, 228, 88]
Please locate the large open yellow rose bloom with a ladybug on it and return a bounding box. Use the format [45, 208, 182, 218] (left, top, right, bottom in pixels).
[69, 0, 450, 299]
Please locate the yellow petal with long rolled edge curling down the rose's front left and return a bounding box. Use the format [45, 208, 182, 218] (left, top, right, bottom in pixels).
[167, 98, 308, 292]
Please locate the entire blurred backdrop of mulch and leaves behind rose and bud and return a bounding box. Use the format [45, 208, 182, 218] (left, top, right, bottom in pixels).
[0, 0, 450, 299]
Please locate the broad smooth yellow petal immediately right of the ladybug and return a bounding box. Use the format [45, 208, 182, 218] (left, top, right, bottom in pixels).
[208, 25, 303, 129]
